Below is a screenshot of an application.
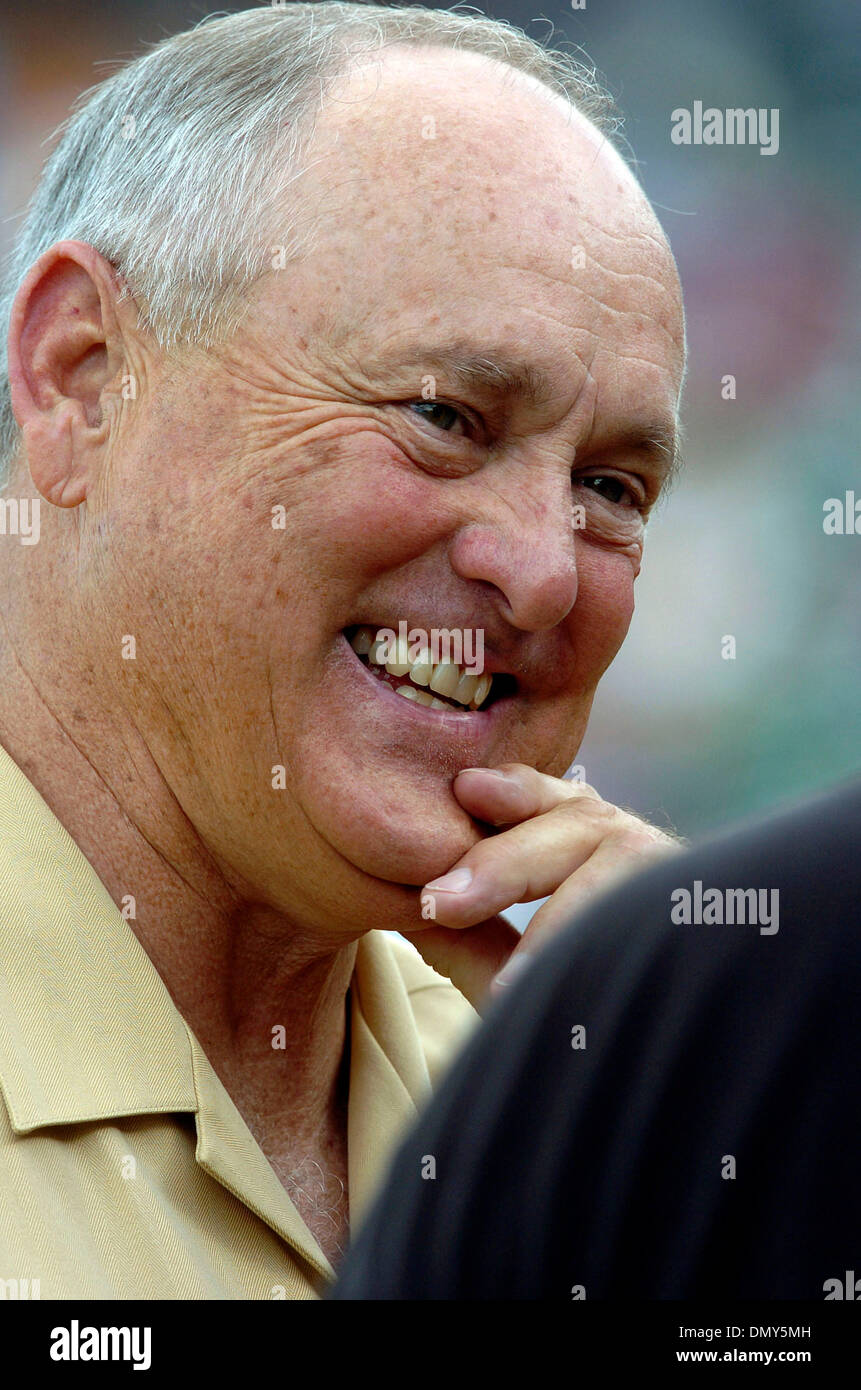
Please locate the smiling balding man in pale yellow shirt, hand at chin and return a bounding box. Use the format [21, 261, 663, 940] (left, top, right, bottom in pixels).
[0, 4, 684, 1298]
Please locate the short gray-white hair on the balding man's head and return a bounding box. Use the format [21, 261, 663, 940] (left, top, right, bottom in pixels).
[0, 0, 620, 485]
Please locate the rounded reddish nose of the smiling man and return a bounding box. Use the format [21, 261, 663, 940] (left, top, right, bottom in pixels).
[449, 475, 577, 632]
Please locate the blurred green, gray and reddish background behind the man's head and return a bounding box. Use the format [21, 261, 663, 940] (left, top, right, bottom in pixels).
[0, 0, 861, 878]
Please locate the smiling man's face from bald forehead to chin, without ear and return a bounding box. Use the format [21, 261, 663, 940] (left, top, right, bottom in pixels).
[88, 50, 683, 933]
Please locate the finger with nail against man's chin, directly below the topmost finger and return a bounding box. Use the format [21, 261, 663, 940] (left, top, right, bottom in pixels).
[421, 799, 625, 927]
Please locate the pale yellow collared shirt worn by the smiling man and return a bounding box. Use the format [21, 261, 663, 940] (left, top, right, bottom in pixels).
[0, 746, 477, 1298]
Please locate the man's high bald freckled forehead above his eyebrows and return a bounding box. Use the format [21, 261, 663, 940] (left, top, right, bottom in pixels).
[250, 46, 683, 422]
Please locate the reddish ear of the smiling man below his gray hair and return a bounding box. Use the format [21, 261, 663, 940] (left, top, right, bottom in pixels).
[8, 242, 127, 507]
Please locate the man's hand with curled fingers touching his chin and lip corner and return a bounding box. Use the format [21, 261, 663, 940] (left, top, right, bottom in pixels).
[405, 763, 682, 1009]
